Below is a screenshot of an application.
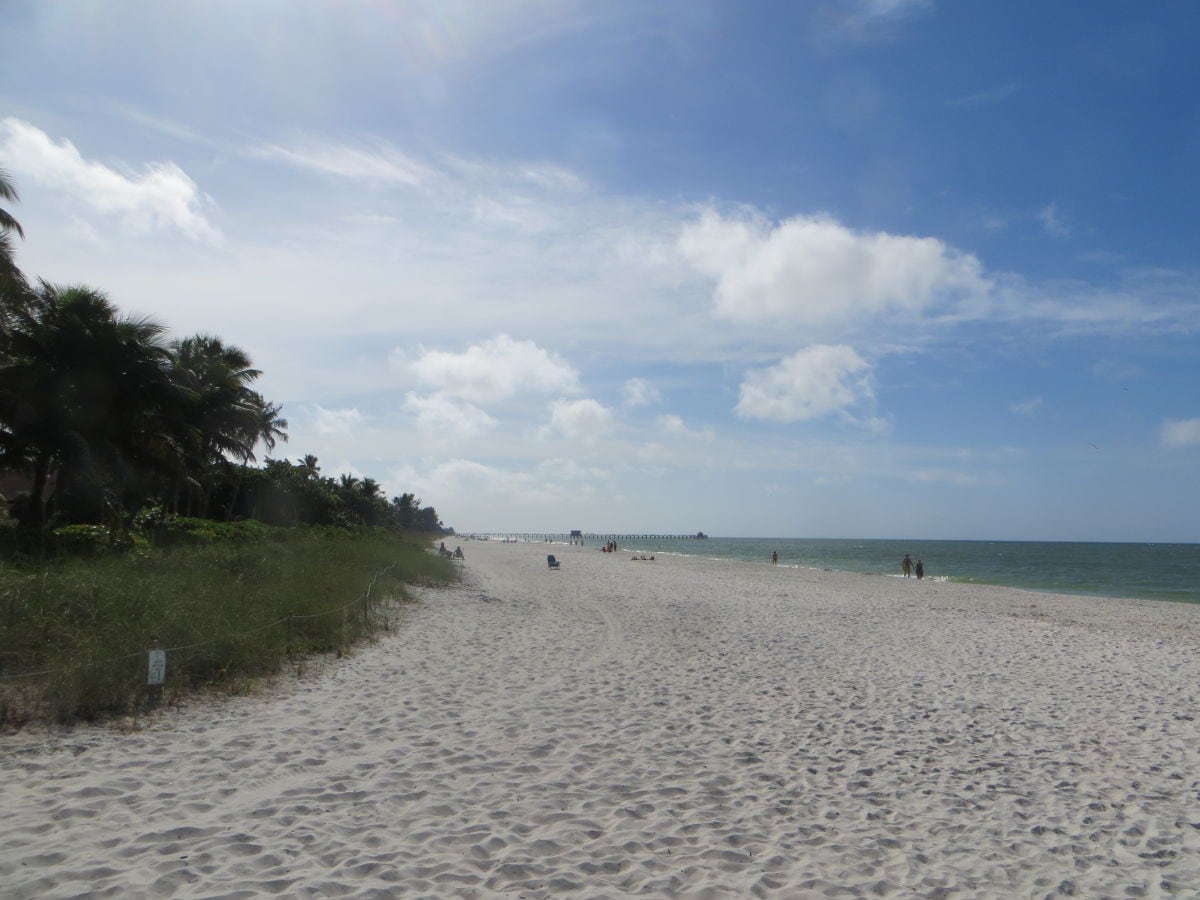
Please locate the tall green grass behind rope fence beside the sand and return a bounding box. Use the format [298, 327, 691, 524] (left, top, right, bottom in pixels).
[0, 529, 456, 722]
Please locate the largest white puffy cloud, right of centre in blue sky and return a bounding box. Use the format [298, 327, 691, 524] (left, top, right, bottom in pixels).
[679, 210, 989, 323]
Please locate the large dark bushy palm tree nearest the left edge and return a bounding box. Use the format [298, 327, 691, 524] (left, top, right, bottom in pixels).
[0, 281, 182, 524]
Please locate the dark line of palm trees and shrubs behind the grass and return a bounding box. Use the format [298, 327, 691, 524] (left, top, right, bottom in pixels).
[0, 170, 443, 540]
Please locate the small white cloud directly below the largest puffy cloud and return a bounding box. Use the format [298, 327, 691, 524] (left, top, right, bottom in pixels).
[736, 344, 874, 422]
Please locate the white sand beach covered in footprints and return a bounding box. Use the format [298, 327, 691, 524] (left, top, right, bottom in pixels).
[0, 542, 1200, 898]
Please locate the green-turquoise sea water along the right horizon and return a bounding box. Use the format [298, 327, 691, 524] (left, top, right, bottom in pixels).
[620, 538, 1200, 604]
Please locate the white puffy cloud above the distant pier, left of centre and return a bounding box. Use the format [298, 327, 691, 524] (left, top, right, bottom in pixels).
[412, 335, 580, 403]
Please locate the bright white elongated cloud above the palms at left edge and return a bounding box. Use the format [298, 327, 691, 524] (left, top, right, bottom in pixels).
[0, 118, 221, 241]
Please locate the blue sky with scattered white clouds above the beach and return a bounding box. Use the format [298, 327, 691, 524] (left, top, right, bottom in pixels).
[0, 0, 1200, 542]
